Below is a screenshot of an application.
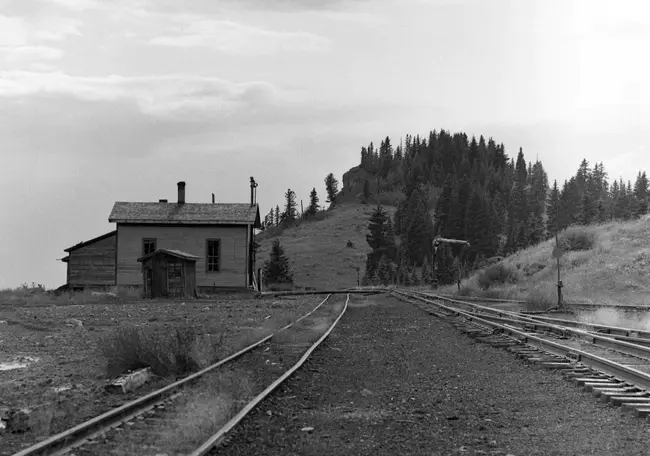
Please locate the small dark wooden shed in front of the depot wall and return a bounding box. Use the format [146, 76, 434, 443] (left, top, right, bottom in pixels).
[138, 249, 199, 298]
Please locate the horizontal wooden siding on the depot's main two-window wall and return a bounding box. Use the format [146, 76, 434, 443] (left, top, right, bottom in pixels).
[117, 223, 248, 288]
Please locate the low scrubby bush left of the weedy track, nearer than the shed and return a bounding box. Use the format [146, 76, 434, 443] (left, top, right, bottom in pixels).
[100, 326, 200, 377]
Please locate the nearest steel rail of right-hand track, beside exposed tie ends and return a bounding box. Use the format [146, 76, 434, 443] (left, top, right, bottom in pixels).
[394, 290, 650, 390]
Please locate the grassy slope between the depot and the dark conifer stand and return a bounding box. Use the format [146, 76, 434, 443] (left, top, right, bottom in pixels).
[256, 204, 395, 289]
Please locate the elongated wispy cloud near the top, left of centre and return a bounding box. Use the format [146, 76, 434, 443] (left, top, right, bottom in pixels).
[148, 17, 330, 54]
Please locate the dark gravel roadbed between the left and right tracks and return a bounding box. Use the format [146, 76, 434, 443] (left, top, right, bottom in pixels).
[214, 296, 650, 456]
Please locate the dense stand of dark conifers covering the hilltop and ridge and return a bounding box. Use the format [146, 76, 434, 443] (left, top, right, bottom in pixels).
[344, 130, 650, 280]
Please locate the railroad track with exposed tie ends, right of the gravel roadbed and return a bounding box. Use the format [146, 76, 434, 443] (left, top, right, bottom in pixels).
[393, 290, 650, 417]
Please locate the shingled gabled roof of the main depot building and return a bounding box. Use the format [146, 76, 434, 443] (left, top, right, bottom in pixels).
[108, 201, 260, 227]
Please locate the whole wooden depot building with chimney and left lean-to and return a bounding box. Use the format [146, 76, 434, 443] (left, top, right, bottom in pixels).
[62, 177, 260, 294]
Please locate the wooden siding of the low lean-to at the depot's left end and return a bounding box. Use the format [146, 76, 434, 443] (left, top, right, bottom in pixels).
[68, 235, 117, 287]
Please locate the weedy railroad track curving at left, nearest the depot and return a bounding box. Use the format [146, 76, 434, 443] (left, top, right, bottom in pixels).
[14, 293, 350, 456]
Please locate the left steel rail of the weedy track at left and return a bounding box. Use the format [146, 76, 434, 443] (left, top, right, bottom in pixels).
[13, 294, 331, 456]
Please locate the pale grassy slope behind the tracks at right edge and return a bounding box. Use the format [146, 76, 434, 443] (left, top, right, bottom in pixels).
[445, 216, 650, 304]
